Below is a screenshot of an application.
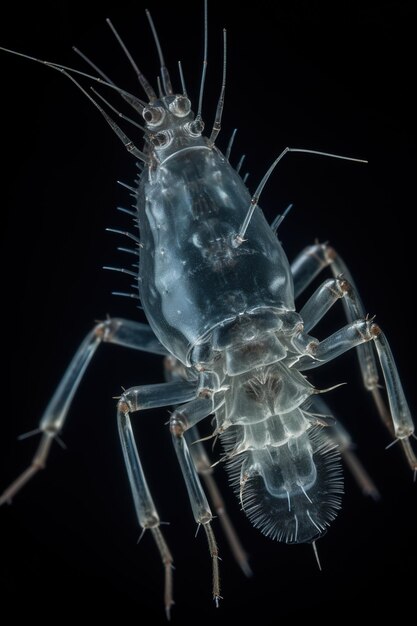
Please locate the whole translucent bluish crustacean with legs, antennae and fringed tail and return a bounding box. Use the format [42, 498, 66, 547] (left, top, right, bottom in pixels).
[0, 0, 416, 611]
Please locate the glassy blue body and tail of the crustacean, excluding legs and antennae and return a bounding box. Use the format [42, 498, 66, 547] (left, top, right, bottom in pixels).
[137, 100, 342, 542]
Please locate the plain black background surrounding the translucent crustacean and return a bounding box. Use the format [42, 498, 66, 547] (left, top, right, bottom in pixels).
[0, 0, 417, 624]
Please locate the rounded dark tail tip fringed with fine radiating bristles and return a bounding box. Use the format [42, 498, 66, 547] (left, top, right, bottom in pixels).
[222, 427, 343, 543]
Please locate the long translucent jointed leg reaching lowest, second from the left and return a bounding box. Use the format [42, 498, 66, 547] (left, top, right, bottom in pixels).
[117, 381, 201, 618]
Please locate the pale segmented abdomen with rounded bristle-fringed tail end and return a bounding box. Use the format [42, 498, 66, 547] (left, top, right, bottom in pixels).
[219, 363, 343, 543]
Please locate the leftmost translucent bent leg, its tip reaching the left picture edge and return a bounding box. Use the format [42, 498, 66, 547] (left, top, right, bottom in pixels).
[0, 318, 166, 506]
